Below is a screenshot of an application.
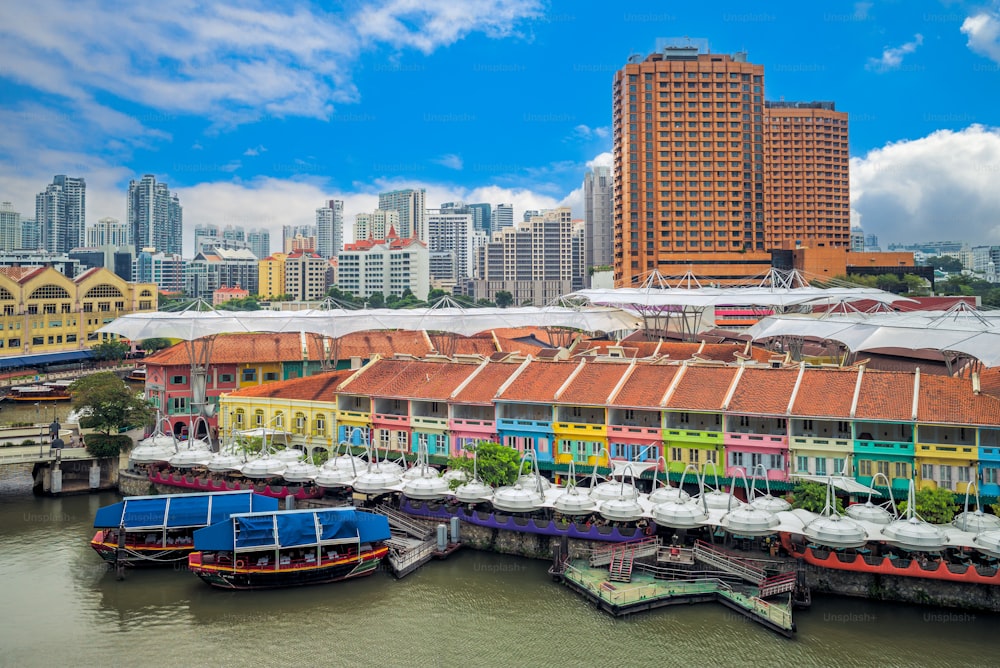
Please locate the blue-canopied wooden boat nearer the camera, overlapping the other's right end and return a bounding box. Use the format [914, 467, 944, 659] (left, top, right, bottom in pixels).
[188, 508, 390, 589]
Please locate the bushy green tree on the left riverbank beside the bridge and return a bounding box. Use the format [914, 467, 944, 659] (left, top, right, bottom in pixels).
[69, 371, 155, 446]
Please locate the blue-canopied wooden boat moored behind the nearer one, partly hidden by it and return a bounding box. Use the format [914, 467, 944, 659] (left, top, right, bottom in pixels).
[90, 491, 279, 566]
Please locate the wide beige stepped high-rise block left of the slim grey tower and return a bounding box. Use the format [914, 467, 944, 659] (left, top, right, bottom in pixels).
[471, 207, 583, 306]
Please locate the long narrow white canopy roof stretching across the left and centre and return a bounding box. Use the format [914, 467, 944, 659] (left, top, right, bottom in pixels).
[98, 306, 641, 341]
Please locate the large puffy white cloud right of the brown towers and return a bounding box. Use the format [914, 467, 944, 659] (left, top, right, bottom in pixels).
[851, 125, 1000, 245]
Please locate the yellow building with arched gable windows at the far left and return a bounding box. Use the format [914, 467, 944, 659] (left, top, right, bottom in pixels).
[0, 267, 157, 367]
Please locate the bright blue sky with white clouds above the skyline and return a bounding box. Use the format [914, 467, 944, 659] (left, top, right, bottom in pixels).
[0, 0, 1000, 256]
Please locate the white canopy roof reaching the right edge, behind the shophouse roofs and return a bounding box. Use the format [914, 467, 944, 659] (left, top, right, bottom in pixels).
[746, 308, 1000, 366]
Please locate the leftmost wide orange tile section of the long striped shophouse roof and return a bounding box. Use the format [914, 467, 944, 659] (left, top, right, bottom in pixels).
[340, 359, 476, 401]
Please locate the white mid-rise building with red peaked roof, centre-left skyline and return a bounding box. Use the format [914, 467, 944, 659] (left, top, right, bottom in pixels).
[337, 229, 430, 299]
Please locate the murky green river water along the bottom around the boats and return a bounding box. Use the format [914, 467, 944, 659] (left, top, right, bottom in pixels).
[0, 475, 1000, 668]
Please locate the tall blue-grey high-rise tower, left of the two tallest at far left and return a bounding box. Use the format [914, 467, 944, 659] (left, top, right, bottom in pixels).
[35, 174, 87, 253]
